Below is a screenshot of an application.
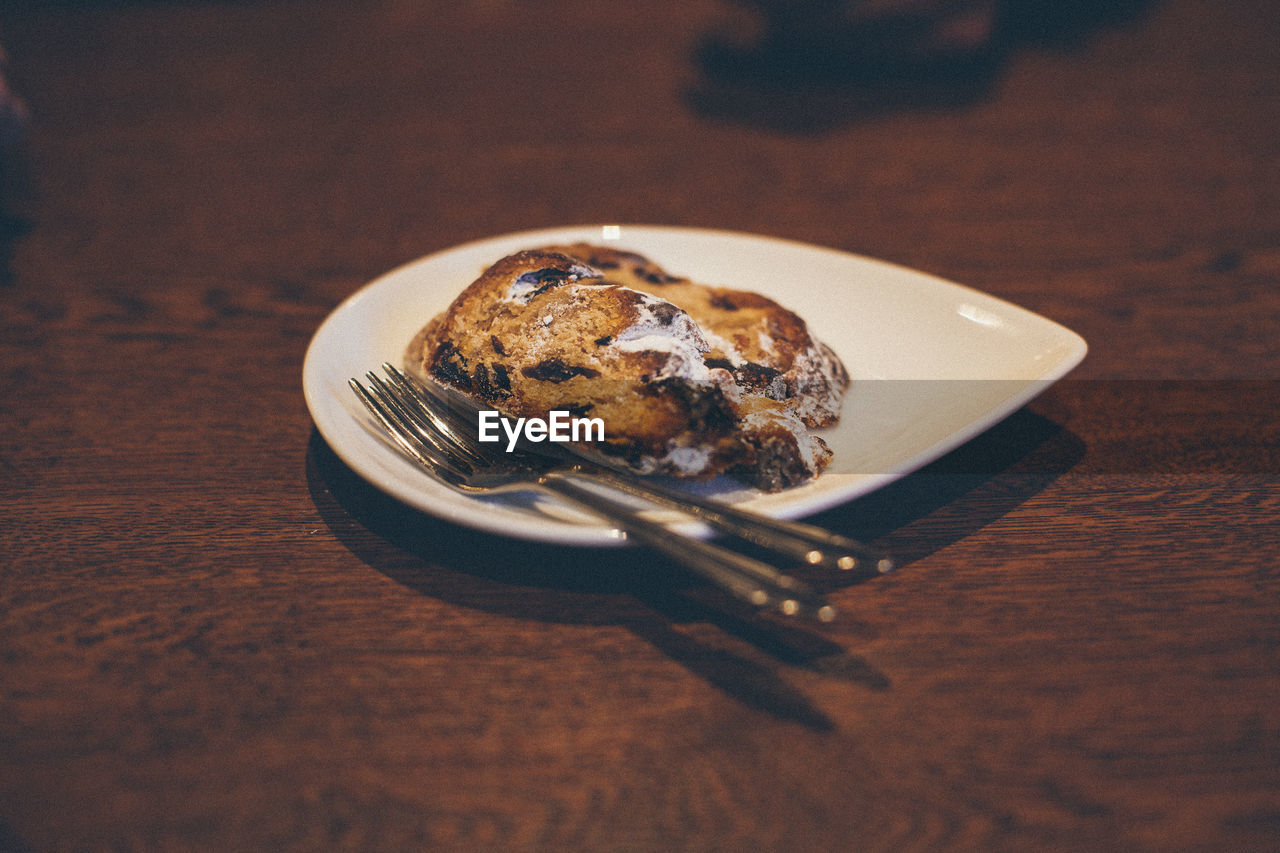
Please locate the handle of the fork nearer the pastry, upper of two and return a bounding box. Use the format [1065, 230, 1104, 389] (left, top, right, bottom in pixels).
[555, 461, 893, 574]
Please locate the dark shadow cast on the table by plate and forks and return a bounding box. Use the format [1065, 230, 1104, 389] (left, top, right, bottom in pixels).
[307, 410, 1084, 730]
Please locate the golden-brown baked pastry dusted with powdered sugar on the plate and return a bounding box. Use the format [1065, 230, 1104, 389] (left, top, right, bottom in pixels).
[406, 250, 847, 491]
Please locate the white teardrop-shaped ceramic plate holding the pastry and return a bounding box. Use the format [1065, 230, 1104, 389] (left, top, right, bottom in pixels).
[302, 225, 1085, 546]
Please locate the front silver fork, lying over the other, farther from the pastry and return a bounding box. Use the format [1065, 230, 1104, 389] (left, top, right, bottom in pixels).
[349, 365, 836, 622]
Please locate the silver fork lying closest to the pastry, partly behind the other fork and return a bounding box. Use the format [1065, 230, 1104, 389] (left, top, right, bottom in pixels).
[383, 364, 893, 575]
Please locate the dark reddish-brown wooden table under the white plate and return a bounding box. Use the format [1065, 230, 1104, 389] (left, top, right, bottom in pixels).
[0, 0, 1280, 852]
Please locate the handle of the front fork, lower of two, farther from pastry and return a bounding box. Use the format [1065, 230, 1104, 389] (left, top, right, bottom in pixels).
[538, 478, 836, 622]
